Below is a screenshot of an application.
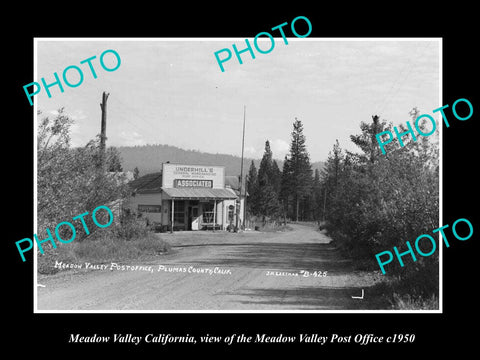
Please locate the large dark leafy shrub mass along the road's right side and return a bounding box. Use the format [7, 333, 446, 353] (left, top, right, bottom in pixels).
[323, 112, 439, 304]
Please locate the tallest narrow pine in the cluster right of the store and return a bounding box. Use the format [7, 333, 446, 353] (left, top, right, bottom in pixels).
[287, 118, 312, 221]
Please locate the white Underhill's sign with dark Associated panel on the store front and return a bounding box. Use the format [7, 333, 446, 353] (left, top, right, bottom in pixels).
[162, 164, 225, 189]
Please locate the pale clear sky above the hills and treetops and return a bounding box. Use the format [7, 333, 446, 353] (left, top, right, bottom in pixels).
[34, 37, 443, 161]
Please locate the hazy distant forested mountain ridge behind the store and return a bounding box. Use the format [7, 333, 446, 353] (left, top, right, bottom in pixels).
[117, 145, 324, 175]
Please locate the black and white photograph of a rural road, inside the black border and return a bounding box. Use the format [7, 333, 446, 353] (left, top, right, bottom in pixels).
[32, 36, 440, 312]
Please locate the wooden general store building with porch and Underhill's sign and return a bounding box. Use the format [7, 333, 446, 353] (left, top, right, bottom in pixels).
[128, 163, 245, 231]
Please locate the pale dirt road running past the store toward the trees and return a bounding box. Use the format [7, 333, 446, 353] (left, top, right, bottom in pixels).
[37, 225, 384, 311]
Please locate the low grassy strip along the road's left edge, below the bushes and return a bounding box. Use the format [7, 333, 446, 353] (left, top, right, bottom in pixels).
[37, 232, 170, 274]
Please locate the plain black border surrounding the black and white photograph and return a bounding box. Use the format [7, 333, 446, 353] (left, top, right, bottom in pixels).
[5, 3, 480, 358]
